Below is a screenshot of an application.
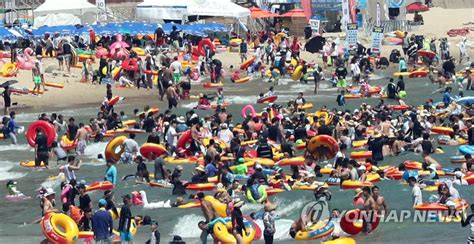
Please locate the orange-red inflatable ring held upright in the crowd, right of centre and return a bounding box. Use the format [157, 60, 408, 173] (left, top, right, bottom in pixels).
[306, 135, 339, 159]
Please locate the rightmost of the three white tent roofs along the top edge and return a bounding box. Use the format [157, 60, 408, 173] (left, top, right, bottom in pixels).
[188, 0, 250, 18]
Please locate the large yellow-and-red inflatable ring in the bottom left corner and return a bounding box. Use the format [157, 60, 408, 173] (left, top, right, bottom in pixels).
[40, 213, 79, 243]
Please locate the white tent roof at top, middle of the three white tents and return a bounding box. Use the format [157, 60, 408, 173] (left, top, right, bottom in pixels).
[137, 0, 189, 21]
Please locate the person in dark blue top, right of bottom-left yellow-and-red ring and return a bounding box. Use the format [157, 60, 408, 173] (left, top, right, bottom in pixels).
[91, 199, 114, 243]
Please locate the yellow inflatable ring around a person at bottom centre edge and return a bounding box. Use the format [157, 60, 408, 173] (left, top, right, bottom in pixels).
[212, 218, 256, 243]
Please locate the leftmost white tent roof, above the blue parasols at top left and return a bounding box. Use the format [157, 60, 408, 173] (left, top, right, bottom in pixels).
[33, 0, 97, 25]
